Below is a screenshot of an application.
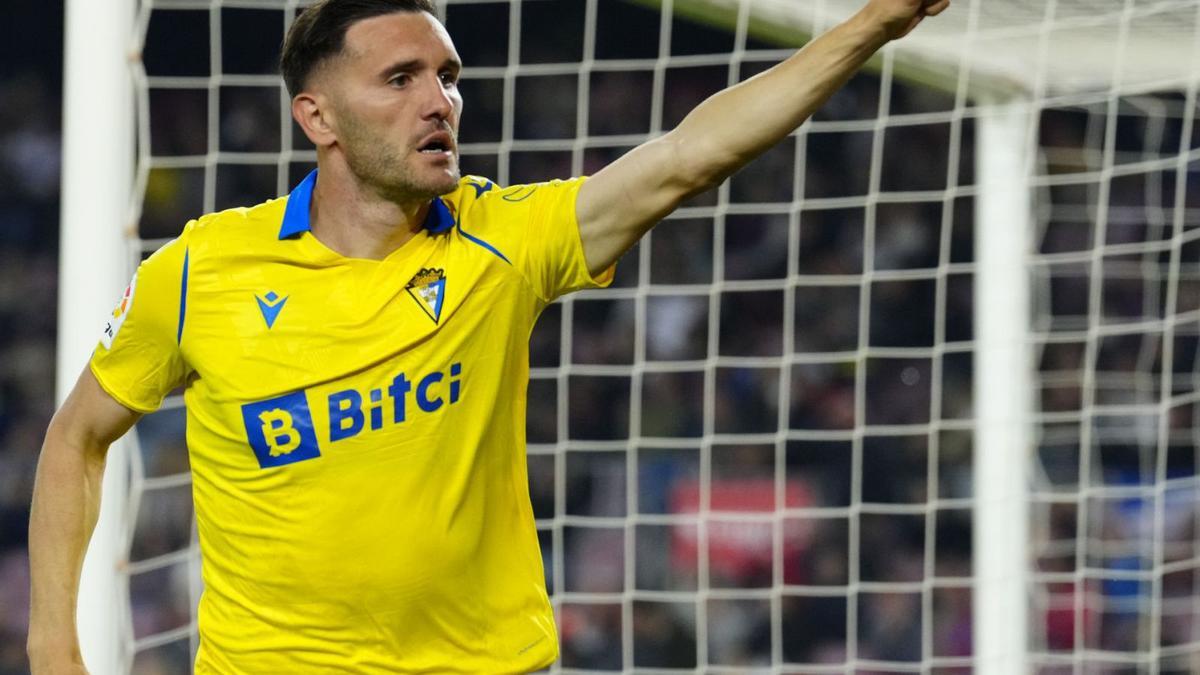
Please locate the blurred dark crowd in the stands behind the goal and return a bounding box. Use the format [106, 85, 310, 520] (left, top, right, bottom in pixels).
[0, 0, 1200, 675]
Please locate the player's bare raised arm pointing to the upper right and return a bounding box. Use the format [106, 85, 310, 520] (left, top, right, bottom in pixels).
[576, 0, 950, 274]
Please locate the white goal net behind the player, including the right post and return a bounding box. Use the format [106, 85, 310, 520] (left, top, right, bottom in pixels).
[60, 0, 1200, 674]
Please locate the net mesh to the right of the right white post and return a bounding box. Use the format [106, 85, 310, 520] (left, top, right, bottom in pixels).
[1032, 90, 1200, 673]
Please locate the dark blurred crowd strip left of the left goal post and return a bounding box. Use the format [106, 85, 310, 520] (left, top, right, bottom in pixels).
[0, 1, 62, 675]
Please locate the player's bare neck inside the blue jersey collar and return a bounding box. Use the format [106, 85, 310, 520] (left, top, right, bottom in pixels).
[308, 160, 430, 261]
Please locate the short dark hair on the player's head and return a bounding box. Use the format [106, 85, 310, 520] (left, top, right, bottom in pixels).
[280, 0, 437, 96]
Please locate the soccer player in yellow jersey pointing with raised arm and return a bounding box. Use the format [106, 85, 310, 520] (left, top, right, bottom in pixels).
[28, 0, 949, 675]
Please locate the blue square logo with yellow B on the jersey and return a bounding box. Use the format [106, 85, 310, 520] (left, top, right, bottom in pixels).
[241, 392, 320, 468]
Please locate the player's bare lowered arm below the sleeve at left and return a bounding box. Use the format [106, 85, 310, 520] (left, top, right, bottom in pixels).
[26, 369, 140, 673]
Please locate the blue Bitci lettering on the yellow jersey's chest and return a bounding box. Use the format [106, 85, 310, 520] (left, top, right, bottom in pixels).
[329, 363, 462, 443]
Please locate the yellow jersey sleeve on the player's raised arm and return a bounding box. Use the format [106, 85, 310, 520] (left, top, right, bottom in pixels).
[461, 178, 613, 303]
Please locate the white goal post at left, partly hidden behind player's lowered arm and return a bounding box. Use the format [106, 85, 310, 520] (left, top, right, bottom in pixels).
[56, 0, 136, 674]
